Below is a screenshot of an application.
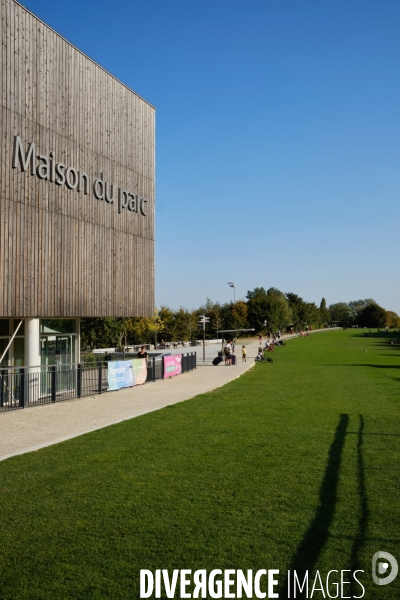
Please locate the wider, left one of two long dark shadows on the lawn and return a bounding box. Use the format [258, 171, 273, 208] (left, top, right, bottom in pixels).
[279, 414, 349, 598]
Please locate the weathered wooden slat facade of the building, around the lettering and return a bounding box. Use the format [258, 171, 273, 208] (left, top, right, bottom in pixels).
[0, 0, 155, 317]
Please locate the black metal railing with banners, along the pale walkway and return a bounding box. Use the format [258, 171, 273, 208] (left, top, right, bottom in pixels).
[0, 352, 196, 412]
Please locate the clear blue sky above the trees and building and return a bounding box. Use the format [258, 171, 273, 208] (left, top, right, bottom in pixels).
[23, 0, 400, 314]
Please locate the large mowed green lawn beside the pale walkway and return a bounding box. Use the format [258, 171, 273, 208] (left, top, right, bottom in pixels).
[0, 330, 400, 600]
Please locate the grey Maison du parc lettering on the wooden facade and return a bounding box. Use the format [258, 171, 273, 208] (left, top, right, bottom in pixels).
[12, 135, 148, 217]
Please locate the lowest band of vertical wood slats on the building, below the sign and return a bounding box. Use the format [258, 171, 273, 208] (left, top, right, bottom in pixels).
[0, 198, 153, 316]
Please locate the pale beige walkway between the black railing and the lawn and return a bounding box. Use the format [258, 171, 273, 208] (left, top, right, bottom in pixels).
[0, 332, 338, 461]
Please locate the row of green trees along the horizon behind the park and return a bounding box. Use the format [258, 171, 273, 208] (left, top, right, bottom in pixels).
[81, 287, 400, 349]
